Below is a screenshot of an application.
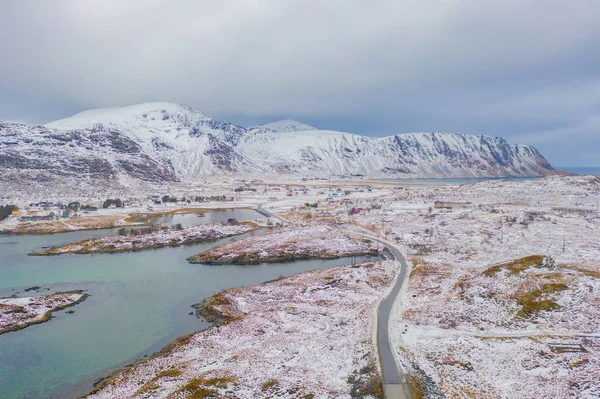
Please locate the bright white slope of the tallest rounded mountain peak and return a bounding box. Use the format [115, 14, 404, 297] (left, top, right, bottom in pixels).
[46, 102, 256, 179]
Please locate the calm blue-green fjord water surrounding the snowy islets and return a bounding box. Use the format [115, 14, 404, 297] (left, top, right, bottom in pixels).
[0, 210, 370, 399]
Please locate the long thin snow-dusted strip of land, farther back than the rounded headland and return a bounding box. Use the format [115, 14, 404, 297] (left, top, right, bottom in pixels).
[30, 222, 259, 256]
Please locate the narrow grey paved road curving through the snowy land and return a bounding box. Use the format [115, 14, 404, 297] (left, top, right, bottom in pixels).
[361, 234, 414, 399]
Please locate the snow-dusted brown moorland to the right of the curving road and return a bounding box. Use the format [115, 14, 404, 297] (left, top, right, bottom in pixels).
[338, 176, 600, 398]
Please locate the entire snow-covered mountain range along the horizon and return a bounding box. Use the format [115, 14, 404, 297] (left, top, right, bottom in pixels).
[0, 103, 555, 185]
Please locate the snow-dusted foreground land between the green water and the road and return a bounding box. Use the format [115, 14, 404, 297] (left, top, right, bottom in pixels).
[90, 261, 398, 399]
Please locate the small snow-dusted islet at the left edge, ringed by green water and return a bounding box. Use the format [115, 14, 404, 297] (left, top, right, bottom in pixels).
[0, 291, 89, 335]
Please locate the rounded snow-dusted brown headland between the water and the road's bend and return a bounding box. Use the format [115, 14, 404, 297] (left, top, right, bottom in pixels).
[188, 224, 379, 265]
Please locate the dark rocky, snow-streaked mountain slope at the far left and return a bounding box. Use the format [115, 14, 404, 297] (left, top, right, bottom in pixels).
[0, 122, 177, 181]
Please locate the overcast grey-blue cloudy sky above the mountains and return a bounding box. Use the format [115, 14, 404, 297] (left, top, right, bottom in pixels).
[0, 0, 600, 166]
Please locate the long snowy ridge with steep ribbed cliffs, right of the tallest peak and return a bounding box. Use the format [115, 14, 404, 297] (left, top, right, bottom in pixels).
[238, 130, 552, 177]
